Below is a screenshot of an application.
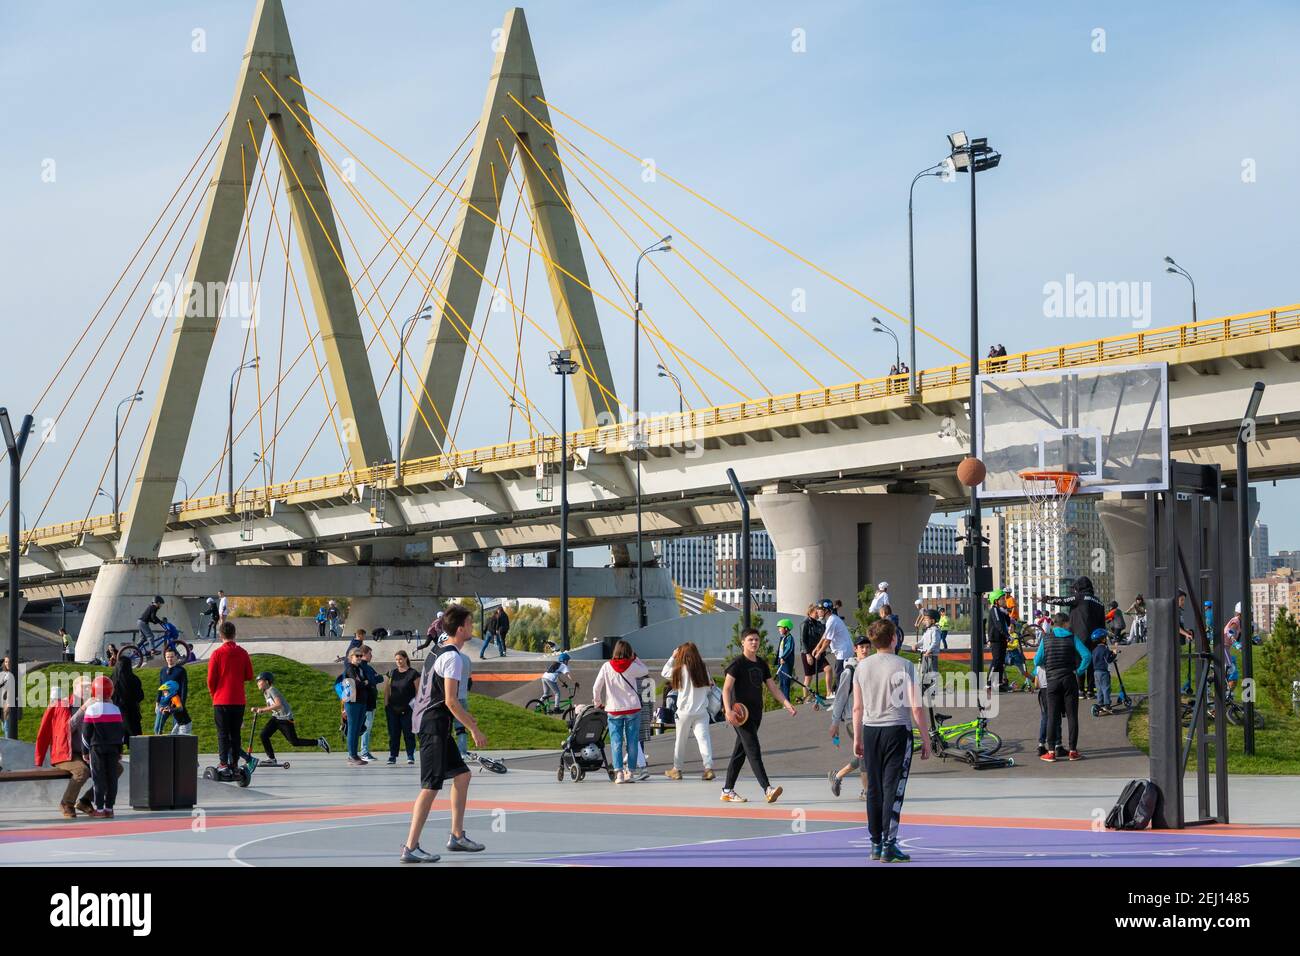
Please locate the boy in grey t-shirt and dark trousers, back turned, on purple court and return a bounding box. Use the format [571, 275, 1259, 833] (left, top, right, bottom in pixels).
[853, 620, 930, 864]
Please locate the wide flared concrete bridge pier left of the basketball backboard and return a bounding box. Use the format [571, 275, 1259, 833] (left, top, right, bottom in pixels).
[755, 483, 935, 628]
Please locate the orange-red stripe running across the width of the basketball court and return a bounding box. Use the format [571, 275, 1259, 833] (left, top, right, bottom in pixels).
[0, 800, 1300, 844]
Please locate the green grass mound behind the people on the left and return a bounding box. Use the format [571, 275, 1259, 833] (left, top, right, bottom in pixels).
[18, 654, 568, 756]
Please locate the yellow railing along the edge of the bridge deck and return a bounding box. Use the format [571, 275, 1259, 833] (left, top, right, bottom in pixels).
[10, 303, 1300, 548]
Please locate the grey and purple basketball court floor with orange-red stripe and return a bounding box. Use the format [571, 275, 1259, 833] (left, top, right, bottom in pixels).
[0, 753, 1300, 868]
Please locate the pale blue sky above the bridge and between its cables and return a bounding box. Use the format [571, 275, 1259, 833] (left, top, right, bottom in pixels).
[0, 0, 1300, 549]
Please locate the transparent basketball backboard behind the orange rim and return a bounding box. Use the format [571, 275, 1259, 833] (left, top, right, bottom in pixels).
[975, 363, 1169, 498]
